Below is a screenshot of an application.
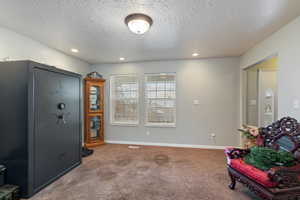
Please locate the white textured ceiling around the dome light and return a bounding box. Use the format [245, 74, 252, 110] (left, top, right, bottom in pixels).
[0, 0, 300, 63]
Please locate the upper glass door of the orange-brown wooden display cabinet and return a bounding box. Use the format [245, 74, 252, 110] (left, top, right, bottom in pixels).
[88, 81, 103, 112]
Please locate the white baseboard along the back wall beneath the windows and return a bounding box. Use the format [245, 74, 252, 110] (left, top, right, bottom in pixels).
[105, 140, 228, 149]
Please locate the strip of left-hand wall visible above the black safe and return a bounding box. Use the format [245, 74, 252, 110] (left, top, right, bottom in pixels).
[0, 27, 90, 75]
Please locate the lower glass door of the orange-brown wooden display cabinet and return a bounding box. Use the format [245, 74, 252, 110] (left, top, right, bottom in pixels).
[88, 114, 104, 142]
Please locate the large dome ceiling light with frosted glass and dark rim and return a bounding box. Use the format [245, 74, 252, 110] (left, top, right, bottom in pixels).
[125, 13, 153, 35]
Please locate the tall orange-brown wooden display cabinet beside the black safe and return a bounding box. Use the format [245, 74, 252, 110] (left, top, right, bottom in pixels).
[84, 77, 105, 147]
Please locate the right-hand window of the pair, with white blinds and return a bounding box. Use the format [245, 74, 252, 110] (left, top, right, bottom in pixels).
[145, 73, 176, 127]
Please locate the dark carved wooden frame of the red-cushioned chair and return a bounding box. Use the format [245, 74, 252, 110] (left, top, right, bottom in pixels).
[227, 117, 300, 200]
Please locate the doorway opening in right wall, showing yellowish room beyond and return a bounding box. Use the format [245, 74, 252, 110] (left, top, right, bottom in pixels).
[244, 56, 278, 127]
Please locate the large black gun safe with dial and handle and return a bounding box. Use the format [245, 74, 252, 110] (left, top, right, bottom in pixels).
[0, 61, 81, 198]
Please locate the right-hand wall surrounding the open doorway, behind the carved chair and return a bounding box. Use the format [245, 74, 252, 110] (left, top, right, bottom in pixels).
[240, 17, 300, 120]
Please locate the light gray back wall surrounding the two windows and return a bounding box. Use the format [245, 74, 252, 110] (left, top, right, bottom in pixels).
[92, 58, 239, 146]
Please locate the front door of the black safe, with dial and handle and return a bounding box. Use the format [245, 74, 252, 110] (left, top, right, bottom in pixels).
[34, 68, 80, 189]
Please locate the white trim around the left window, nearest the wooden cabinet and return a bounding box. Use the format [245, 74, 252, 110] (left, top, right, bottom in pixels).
[109, 74, 140, 126]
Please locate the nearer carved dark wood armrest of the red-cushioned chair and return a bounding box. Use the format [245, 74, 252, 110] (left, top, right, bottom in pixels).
[268, 164, 300, 188]
